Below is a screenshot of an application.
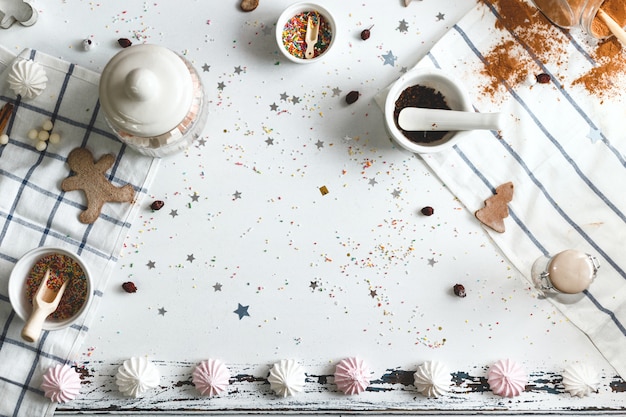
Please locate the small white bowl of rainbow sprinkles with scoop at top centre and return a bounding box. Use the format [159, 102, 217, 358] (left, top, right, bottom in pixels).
[276, 3, 336, 64]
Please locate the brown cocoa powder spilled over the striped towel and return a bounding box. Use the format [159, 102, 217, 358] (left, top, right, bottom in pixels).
[479, 0, 626, 97]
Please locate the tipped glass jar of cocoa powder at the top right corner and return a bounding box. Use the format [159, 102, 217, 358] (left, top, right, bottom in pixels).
[532, 0, 626, 39]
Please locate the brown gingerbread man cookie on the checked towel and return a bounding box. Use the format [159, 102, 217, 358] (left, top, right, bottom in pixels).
[61, 148, 135, 224]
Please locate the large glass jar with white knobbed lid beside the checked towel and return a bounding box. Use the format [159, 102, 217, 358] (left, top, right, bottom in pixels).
[100, 44, 207, 158]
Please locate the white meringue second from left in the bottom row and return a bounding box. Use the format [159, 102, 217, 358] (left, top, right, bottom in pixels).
[115, 357, 161, 398]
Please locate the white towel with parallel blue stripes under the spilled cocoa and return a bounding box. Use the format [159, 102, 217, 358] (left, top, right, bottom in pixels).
[380, 0, 626, 377]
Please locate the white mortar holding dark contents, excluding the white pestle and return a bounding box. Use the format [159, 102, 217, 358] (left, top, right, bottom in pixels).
[385, 68, 474, 154]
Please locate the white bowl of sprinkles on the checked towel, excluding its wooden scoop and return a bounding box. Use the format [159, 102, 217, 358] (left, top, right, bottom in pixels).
[9, 246, 92, 330]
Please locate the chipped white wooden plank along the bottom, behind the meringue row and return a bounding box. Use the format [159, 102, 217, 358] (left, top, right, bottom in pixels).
[57, 361, 626, 415]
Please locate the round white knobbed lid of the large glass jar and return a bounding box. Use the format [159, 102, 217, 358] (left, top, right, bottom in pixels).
[100, 44, 194, 137]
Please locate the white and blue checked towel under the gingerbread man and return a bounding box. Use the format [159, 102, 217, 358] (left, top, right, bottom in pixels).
[0, 47, 158, 417]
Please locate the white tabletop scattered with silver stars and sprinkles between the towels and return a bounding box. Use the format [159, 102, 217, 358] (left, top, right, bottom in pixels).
[0, 0, 626, 415]
